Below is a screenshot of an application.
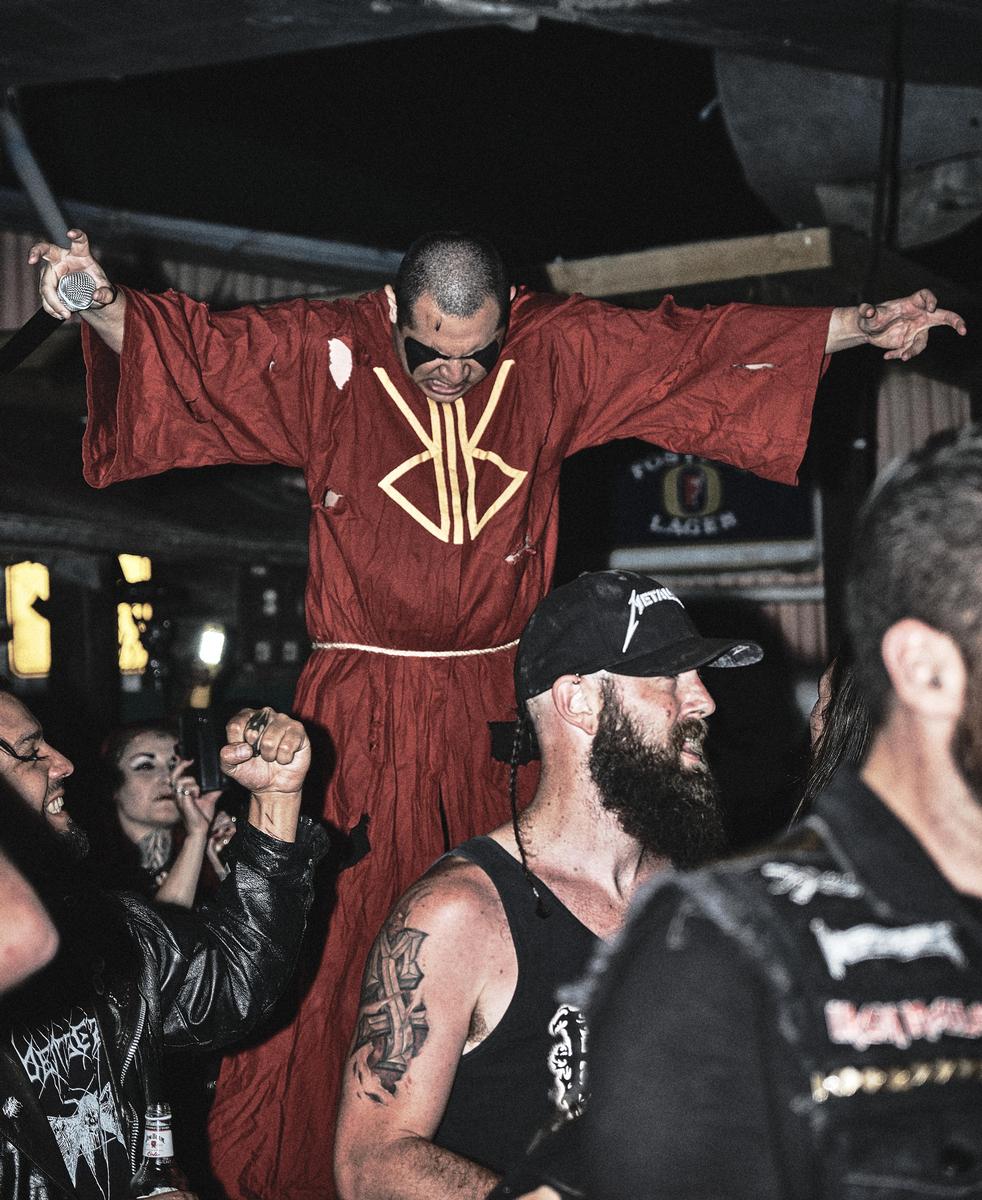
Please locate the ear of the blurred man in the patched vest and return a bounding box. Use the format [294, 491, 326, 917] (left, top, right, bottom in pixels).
[880, 617, 966, 720]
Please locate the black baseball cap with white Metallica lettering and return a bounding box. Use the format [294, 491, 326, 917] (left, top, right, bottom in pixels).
[515, 571, 764, 707]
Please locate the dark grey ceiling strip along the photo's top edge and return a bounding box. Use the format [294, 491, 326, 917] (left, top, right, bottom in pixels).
[0, 0, 982, 86]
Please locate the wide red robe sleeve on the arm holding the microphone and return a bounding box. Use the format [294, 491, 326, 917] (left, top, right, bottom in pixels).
[83, 289, 333, 487]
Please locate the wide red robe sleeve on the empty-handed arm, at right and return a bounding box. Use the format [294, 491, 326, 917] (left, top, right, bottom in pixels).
[557, 296, 831, 484]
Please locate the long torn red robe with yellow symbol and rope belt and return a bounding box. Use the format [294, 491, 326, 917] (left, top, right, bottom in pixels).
[84, 292, 830, 1200]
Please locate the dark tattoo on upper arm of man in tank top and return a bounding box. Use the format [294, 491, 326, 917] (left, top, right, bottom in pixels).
[354, 902, 430, 1096]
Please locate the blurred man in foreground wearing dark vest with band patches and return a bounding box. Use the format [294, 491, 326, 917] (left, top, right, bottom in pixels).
[559, 426, 982, 1200]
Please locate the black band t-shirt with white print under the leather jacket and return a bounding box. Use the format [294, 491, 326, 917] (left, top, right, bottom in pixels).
[11, 1007, 132, 1200]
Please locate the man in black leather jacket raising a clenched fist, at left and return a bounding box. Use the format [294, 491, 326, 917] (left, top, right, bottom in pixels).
[0, 679, 318, 1200]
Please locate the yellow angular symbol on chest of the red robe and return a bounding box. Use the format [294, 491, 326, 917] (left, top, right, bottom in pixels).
[375, 359, 528, 546]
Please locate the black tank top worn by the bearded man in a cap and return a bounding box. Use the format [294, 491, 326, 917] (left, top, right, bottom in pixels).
[433, 838, 600, 1172]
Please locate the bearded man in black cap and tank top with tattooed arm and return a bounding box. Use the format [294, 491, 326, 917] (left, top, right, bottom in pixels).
[335, 571, 761, 1200]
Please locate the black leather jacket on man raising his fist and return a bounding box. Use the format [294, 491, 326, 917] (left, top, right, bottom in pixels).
[0, 820, 327, 1200]
